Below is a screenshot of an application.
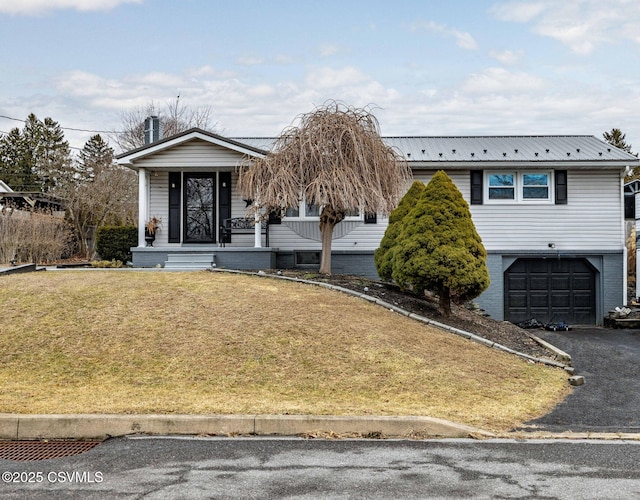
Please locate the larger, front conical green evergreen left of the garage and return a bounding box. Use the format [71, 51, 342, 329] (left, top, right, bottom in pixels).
[392, 171, 489, 316]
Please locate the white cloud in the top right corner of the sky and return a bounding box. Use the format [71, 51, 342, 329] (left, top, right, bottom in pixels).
[491, 0, 640, 55]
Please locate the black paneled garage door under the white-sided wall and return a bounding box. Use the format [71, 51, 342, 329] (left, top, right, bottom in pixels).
[505, 258, 596, 325]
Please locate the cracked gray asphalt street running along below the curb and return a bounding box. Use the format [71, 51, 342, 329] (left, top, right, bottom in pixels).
[0, 437, 640, 500]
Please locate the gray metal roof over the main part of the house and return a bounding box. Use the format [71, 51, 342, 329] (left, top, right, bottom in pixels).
[234, 135, 639, 164]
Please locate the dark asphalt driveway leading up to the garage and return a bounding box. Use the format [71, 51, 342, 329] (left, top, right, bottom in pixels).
[527, 328, 640, 432]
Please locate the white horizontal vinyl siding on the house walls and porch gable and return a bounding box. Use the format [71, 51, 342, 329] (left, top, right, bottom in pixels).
[136, 144, 624, 252]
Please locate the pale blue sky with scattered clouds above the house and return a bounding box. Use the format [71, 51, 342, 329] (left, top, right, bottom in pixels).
[0, 0, 640, 151]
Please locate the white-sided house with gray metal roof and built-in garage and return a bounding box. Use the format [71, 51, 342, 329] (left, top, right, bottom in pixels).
[117, 129, 639, 324]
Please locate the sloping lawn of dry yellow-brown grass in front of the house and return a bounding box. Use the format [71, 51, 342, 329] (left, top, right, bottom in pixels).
[0, 271, 569, 430]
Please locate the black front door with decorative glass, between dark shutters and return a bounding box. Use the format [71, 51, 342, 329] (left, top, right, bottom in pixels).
[183, 174, 216, 243]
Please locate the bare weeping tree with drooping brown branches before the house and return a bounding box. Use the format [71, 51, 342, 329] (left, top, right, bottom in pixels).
[239, 101, 411, 274]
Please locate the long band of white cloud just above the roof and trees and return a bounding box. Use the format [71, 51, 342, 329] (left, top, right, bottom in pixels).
[13, 54, 640, 147]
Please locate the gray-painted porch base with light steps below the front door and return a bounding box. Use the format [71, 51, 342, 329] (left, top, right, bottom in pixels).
[131, 245, 278, 270]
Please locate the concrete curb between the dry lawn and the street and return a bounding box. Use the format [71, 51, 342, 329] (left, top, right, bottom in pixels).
[0, 414, 495, 440]
